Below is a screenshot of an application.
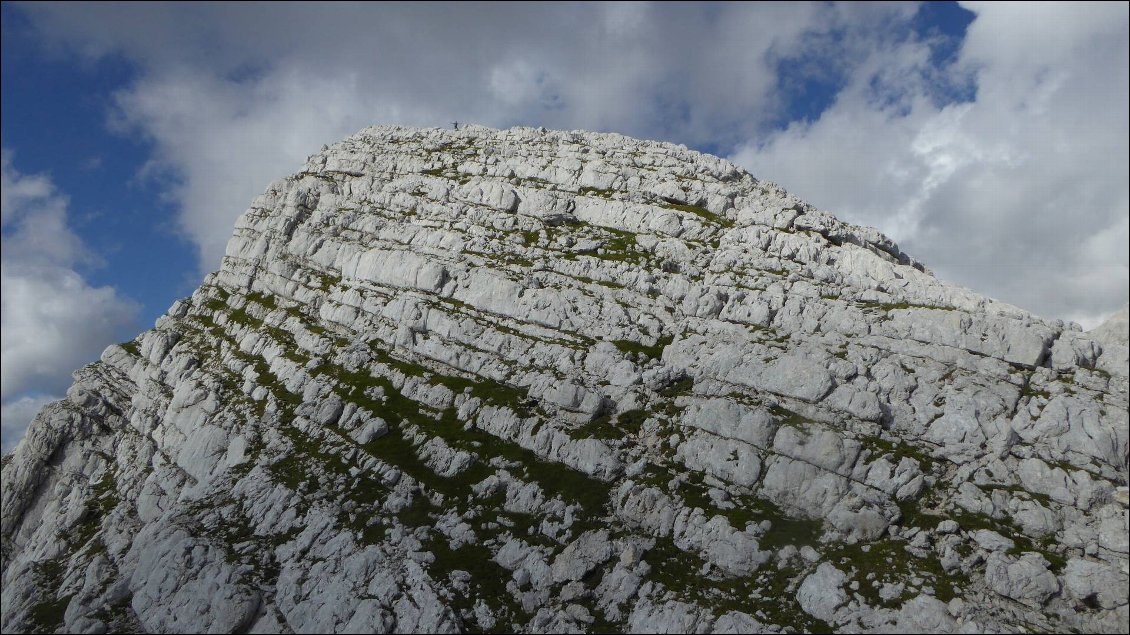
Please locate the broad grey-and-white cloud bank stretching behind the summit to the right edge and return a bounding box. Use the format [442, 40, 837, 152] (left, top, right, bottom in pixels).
[13, 2, 1130, 321]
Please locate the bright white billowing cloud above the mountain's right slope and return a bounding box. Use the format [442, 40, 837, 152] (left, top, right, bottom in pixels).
[733, 2, 1130, 327]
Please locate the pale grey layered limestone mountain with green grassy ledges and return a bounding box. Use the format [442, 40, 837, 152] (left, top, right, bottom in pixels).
[2, 122, 1130, 633]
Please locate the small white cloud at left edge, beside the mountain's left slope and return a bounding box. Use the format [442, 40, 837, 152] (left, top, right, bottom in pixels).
[0, 150, 138, 450]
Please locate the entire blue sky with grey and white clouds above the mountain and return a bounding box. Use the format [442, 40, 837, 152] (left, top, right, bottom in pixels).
[0, 2, 1130, 452]
